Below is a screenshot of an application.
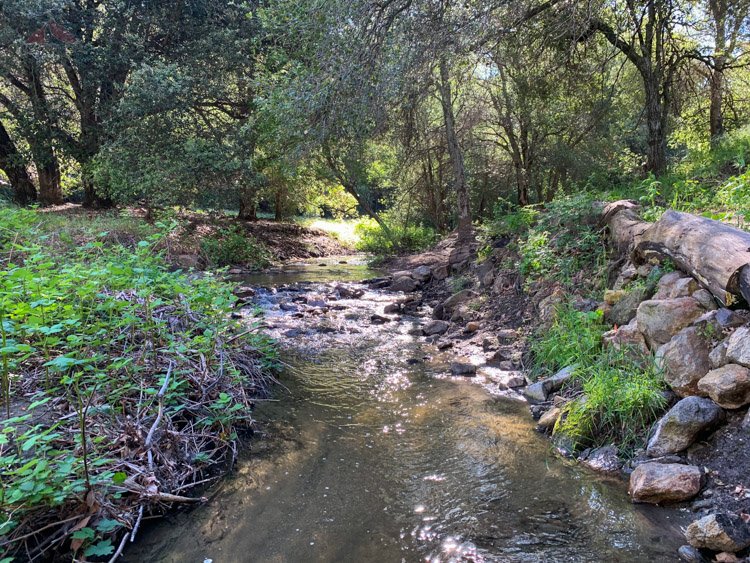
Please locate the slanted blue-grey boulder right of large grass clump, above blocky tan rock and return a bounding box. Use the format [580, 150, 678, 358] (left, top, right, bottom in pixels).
[646, 397, 724, 457]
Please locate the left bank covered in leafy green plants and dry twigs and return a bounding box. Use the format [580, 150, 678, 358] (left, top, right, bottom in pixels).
[0, 208, 276, 561]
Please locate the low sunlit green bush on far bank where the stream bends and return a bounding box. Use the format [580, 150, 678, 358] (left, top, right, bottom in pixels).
[355, 219, 437, 256]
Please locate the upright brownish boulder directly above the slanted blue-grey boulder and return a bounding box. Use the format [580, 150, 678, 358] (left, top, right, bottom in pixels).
[656, 327, 711, 397]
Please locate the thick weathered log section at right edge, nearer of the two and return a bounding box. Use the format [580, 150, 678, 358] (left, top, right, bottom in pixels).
[636, 211, 750, 306]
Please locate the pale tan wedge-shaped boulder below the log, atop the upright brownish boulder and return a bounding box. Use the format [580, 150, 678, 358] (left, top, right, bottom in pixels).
[636, 297, 705, 350]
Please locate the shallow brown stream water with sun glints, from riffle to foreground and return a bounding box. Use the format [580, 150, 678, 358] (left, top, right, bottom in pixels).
[126, 265, 685, 563]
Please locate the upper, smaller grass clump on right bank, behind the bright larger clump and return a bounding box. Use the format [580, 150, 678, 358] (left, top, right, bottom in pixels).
[531, 304, 607, 376]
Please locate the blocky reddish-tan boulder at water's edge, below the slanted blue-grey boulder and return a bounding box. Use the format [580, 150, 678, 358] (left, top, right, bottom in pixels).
[628, 463, 701, 504]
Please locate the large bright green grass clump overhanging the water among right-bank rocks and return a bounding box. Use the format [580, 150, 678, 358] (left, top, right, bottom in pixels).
[554, 349, 667, 455]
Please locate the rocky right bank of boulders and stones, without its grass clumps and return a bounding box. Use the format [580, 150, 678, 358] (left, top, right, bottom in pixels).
[374, 213, 750, 561]
